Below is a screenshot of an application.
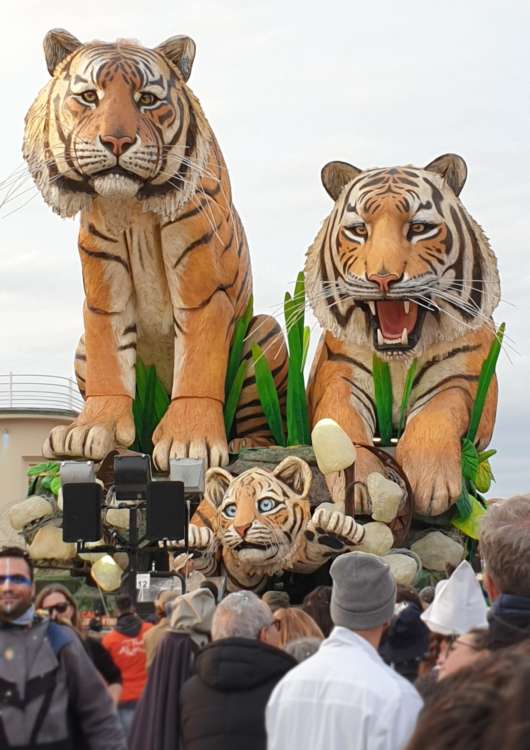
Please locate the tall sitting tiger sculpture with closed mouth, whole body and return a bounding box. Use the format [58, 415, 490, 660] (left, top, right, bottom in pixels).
[24, 29, 287, 469]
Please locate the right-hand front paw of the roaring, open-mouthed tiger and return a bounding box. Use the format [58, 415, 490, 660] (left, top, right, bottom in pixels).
[396, 432, 462, 516]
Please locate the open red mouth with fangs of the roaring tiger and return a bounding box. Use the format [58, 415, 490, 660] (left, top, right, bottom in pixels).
[364, 299, 427, 352]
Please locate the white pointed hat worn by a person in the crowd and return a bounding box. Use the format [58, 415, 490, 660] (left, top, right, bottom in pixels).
[421, 560, 488, 635]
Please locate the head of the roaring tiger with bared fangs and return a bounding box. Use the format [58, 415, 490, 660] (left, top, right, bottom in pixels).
[305, 154, 500, 359]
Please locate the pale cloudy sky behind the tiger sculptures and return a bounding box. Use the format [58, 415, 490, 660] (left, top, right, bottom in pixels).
[0, 0, 530, 496]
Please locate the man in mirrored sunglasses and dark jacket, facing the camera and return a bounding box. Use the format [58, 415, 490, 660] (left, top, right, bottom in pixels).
[0, 547, 126, 750]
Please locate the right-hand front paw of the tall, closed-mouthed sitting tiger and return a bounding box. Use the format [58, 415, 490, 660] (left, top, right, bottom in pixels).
[153, 398, 228, 471]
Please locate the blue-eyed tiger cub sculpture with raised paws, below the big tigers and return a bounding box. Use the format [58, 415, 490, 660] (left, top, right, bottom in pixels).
[184, 456, 379, 591]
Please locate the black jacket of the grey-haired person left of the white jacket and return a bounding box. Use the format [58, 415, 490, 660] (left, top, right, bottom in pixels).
[180, 638, 296, 750]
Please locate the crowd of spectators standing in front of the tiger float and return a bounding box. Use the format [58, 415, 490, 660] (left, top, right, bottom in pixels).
[0, 497, 530, 750]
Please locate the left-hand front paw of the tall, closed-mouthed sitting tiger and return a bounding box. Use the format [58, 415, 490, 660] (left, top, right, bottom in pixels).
[42, 396, 135, 460]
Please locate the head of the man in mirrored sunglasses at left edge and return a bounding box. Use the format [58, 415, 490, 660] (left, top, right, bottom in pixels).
[0, 547, 35, 622]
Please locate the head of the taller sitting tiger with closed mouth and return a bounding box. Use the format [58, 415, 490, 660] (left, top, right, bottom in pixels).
[23, 29, 212, 219]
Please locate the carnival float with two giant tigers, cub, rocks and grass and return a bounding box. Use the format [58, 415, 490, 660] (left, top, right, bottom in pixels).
[10, 29, 504, 604]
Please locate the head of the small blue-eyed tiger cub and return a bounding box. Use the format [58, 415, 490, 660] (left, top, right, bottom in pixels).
[204, 456, 312, 575]
